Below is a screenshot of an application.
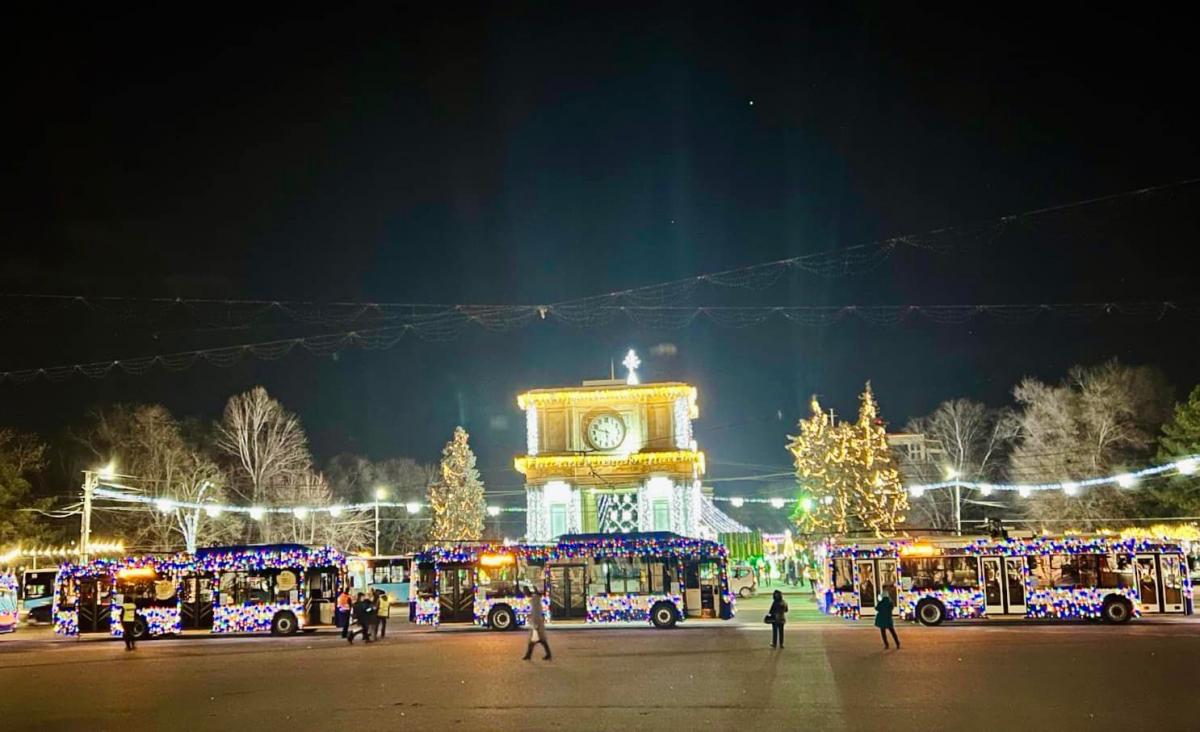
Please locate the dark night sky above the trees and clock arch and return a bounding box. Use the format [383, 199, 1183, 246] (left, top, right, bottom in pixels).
[0, 2, 1200, 530]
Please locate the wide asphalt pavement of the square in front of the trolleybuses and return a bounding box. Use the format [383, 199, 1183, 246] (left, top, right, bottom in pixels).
[0, 593, 1200, 732]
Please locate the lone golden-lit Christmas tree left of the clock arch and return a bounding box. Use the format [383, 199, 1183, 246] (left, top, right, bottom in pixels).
[430, 427, 487, 541]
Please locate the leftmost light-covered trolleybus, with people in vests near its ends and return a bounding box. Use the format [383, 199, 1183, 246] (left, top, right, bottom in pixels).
[54, 544, 346, 638]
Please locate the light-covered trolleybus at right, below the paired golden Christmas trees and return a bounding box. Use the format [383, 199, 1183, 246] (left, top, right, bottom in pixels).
[817, 536, 1192, 625]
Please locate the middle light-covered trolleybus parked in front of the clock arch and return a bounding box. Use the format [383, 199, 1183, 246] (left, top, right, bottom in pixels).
[413, 532, 734, 630]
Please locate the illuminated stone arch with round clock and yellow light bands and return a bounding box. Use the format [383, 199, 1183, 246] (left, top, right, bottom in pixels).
[516, 377, 712, 541]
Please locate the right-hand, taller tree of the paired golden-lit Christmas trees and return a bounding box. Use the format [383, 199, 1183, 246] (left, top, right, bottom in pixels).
[842, 382, 908, 536]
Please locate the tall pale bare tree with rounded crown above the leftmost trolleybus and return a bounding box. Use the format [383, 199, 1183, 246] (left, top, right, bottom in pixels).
[216, 386, 312, 536]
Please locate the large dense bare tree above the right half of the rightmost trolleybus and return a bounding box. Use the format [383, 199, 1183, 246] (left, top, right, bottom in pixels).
[1009, 359, 1171, 528]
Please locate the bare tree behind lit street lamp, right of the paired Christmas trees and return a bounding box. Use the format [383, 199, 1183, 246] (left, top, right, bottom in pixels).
[904, 398, 1018, 532]
